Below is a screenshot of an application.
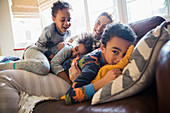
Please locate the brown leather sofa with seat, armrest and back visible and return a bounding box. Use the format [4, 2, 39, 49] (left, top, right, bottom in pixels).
[33, 16, 170, 113]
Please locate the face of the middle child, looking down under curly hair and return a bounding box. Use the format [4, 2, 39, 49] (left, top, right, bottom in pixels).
[71, 44, 86, 58]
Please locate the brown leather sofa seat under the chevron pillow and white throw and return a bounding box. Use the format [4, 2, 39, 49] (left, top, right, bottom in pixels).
[33, 83, 157, 113]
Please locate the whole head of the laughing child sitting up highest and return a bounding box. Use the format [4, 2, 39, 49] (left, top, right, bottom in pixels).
[51, 0, 72, 35]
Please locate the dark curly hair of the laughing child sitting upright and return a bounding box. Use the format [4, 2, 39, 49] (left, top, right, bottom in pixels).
[51, 0, 72, 17]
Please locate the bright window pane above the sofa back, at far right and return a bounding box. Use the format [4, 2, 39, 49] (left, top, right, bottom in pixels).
[126, 0, 168, 22]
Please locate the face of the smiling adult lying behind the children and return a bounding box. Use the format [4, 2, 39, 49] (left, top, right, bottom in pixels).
[93, 16, 111, 40]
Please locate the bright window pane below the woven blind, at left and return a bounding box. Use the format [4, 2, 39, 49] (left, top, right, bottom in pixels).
[13, 18, 42, 48]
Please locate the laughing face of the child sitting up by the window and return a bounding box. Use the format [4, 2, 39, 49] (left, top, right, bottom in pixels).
[52, 9, 71, 34]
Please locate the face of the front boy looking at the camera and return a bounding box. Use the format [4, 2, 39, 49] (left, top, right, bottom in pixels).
[101, 37, 131, 65]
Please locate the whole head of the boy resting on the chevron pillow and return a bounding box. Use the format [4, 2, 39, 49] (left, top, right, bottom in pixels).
[100, 23, 136, 65]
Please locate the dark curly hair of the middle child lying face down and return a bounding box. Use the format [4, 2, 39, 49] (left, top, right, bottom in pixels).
[77, 33, 94, 53]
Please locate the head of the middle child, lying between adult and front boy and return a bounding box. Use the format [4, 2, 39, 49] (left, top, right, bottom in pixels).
[72, 33, 94, 58]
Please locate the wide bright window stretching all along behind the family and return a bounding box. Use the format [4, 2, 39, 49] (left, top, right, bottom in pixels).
[10, 0, 170, 48]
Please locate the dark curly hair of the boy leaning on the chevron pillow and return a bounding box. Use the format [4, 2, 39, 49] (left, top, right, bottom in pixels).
[101, 22, 136, 47]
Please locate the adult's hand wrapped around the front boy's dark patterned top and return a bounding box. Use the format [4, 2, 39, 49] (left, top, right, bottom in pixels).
[69, 61, 81, 82]
